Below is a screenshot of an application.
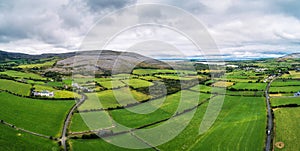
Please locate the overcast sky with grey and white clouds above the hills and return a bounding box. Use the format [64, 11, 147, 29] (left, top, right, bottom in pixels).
[0, 0, 300, 58]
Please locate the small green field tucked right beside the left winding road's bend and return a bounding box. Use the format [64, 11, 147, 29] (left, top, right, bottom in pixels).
[70, 111, 112, 132]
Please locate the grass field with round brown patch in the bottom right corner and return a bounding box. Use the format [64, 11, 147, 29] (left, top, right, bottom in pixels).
[273, 107, 300, 151]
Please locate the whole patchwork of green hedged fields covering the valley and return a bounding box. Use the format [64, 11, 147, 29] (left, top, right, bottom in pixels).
[0, 60, 300, 151]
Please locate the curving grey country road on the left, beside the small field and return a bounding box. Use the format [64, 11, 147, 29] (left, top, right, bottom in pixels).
[60, 95, 86, 151]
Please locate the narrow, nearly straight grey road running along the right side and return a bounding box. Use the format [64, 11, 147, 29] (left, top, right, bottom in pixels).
[265, 77, 276, 151]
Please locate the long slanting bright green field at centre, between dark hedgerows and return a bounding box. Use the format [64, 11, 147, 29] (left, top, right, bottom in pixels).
[110, 90, 211, 128]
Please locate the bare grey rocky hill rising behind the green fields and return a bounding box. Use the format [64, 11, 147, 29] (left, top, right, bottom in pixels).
[49, 50, 170, 74]
